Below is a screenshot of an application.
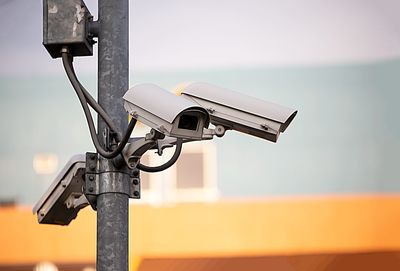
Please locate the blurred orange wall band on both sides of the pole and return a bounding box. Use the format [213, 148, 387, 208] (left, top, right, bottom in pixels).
[0, 196, 400, 264]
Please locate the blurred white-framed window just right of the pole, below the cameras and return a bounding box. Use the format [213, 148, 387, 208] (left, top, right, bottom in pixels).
[133, 142, 219, 204]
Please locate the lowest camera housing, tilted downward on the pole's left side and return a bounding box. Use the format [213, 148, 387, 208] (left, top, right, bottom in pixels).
[33, 155, 88, 225]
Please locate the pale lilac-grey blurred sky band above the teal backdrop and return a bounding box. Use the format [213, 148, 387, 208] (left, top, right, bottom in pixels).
[0, 0, 400, 74]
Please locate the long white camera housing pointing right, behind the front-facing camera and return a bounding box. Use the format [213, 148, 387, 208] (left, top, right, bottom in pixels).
[181, 83, 297, 142]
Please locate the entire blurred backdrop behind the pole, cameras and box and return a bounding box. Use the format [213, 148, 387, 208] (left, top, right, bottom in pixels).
[0, 0, 400, 271]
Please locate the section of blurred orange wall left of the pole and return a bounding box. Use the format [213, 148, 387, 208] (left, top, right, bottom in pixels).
[0, 207, 96, 264]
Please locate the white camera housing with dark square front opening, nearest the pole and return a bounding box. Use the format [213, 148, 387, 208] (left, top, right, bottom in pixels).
[123, 84, 210, 140]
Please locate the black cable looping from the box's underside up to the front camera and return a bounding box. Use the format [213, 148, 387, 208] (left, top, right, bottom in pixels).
[61, 48, 136, 159]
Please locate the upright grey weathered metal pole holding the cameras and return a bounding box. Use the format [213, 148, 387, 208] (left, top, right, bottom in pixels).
[96, 0, 129, 271]
